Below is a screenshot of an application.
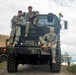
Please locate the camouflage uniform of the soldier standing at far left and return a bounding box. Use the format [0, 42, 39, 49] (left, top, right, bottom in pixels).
[9, 16, 24, 44]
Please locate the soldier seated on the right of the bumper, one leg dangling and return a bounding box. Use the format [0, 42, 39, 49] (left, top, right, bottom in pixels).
[38, 27, 58, 64]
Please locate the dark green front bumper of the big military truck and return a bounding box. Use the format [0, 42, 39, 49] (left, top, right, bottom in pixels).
[7, 47, 50, 55]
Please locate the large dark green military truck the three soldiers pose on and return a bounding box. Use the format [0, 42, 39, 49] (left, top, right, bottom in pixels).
[6, 13, 67, 73]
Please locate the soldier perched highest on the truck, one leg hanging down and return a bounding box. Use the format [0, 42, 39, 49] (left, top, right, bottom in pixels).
[25, 6, 39, 37]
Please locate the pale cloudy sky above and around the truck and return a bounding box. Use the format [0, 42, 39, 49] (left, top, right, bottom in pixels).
[0, 0, 76, 59]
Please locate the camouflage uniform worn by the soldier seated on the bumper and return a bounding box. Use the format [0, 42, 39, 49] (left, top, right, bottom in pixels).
[39, 33, 58, 57]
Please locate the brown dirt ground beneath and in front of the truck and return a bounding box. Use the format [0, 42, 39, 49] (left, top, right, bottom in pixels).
[0, 65, 73, 75]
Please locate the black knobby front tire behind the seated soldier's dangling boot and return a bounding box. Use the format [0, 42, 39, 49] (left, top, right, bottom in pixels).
[50, 46, 61, 73]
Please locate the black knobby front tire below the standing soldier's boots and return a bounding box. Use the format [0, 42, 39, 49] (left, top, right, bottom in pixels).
[7, 54, 18, 73]
